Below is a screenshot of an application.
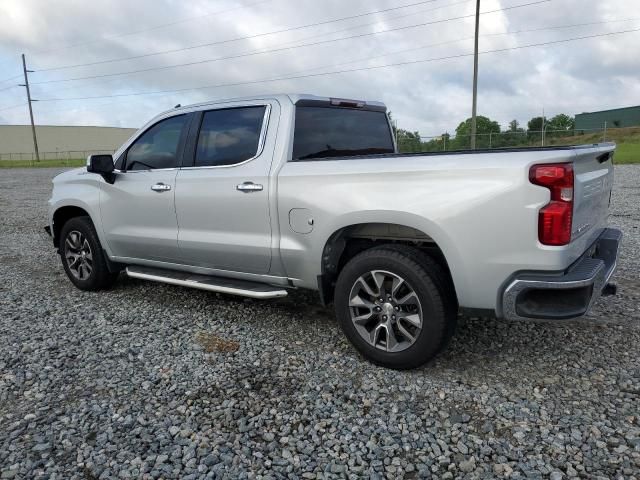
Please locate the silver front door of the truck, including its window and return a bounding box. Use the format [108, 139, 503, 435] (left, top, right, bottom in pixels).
[100, 115, 190, 262]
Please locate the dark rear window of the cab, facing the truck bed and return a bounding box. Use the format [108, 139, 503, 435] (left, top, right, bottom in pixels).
[293, 107, 394, 160]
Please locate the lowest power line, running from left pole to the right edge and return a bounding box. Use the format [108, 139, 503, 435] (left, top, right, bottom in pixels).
[40, 28, 640, 102]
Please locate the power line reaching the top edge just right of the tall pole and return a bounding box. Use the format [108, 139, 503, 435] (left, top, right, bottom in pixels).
[33, 0, 553, 85]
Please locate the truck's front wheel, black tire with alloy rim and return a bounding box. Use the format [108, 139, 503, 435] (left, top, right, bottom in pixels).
[59, 216, 118, 291]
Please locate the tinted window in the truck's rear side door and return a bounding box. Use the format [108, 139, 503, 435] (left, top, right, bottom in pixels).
[195, 106, 266, 167]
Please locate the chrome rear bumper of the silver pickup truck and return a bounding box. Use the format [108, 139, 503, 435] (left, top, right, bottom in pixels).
[501, 228, 622, 320]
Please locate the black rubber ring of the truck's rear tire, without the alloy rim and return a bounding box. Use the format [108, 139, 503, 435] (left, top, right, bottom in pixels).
[334, 248, 447, 369]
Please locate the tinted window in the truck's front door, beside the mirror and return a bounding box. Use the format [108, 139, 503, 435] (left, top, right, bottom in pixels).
[127, 115, 187, 170]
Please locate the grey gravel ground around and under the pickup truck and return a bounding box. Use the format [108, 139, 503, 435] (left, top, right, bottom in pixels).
[0, 166, 640, 480]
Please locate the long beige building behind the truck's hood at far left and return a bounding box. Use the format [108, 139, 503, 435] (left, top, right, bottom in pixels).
[0, 125, 136, 160]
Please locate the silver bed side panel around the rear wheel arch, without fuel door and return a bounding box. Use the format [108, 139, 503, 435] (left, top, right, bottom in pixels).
[278, 150, 592, 309]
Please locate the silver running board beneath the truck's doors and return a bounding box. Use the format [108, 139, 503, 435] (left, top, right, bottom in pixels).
[126, 266, 287, 299]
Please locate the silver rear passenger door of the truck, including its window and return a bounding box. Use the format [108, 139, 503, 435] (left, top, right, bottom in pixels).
[176, 102, 279, 274]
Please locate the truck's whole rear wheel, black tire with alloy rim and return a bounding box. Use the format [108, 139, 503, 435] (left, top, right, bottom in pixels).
[334, 245, 457, 370]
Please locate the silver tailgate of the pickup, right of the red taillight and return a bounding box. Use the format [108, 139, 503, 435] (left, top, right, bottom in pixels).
[571, 144, 615, 242]
